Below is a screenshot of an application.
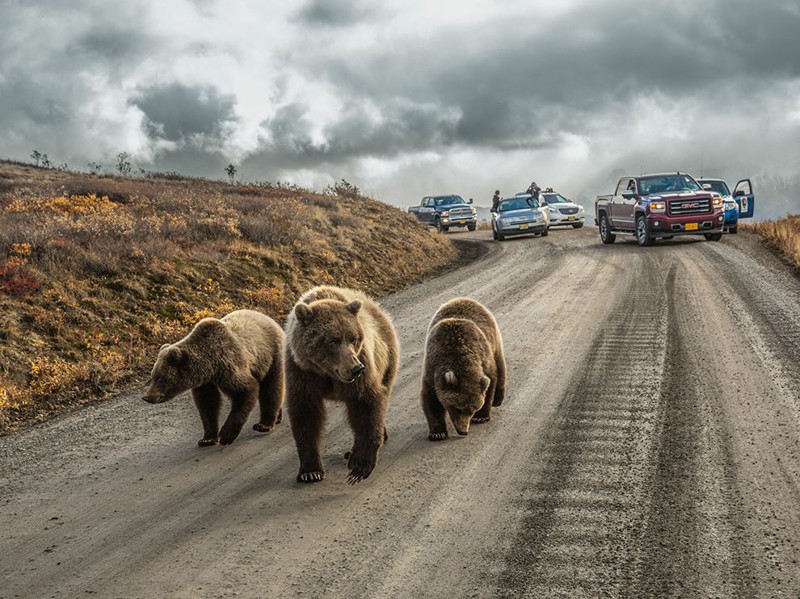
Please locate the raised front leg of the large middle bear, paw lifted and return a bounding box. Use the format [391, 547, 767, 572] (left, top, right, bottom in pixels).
[345, 395, 388, 485]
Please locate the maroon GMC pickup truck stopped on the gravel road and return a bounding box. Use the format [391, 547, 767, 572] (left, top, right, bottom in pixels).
[594, 173, 725, 245]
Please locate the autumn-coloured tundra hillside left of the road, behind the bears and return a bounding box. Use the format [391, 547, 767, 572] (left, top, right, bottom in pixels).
[0, 162, 456, 434]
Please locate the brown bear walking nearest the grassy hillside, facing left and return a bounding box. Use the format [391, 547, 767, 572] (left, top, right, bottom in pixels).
[142, 310, 284, 447]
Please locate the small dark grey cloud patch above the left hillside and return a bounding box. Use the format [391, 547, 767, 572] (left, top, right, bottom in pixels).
[131, 83, 236, 141]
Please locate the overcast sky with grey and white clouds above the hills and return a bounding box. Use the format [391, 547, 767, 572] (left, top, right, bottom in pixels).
[0, 0, 800, 215]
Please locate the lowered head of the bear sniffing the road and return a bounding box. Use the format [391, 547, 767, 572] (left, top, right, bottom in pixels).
[434, 367, 491, 435]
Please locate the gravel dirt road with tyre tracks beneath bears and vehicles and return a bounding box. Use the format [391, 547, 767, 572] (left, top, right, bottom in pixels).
[0, 227, 800, 598]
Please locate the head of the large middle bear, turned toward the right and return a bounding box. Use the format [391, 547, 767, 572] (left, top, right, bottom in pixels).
[292, 299, 366, 383]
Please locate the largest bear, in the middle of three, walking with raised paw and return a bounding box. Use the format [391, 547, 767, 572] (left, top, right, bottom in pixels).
[285, 286, 400, 484]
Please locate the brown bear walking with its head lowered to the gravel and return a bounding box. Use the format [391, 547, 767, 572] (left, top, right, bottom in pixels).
[420, 298, 506, 441]
